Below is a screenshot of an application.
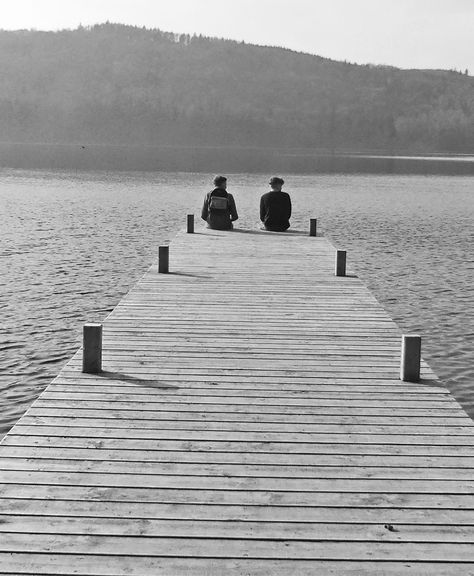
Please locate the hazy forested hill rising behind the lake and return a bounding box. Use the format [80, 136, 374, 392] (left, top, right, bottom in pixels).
[0, 24, 474, 153]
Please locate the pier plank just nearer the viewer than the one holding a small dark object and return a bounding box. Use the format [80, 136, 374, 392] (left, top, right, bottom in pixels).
[0, 532, 474, 562]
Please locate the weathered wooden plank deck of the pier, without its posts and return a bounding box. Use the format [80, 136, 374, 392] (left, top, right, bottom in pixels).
[0, 224, 474, 576]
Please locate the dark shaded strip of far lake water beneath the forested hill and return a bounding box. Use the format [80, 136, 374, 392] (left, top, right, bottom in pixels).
[0, 142, 474, 176]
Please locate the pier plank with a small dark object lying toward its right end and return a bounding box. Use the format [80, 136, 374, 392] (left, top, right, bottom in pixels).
[0, 514, 474, 543]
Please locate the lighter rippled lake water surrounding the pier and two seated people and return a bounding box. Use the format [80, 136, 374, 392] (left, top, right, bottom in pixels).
[0, 169, 474, 434]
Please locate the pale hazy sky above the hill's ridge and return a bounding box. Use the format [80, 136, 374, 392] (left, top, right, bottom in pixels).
[0, 0, 474, 74]
